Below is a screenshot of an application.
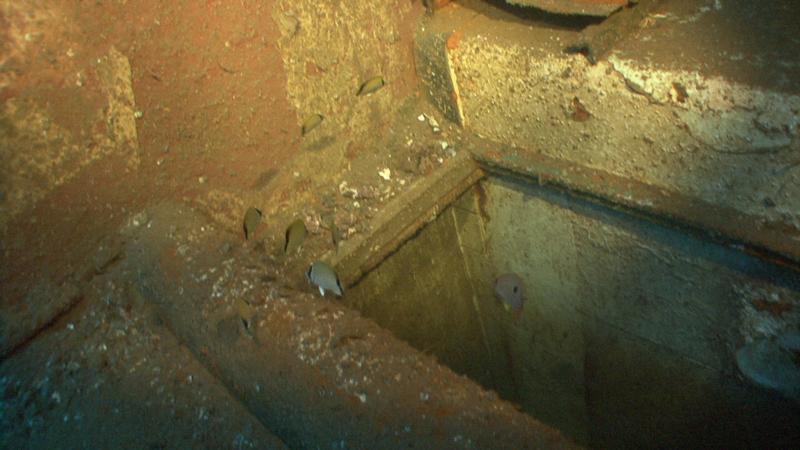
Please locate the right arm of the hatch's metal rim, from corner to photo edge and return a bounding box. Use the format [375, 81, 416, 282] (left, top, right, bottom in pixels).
[464, 137, 800, 274]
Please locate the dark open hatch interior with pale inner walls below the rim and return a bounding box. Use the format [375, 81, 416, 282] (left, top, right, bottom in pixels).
[345, 179, 800, 448]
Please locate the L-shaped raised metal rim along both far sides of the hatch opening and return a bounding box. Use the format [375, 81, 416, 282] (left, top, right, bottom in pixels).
[324, 136, 800, 286]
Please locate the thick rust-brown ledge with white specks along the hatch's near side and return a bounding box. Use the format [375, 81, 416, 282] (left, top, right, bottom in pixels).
[126, 203, 575, 449]
